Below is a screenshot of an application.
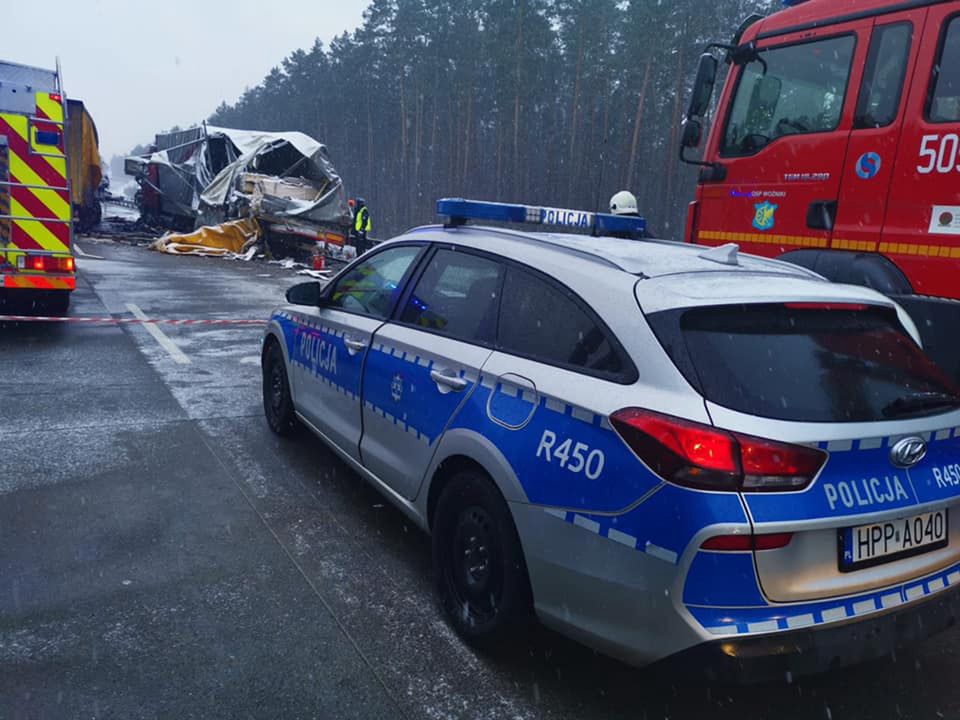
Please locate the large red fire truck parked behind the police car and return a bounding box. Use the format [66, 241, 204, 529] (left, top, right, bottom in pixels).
[681, 0, 960, 377]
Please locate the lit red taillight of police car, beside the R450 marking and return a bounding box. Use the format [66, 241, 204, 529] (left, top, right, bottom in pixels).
[610, 408, 827, 492]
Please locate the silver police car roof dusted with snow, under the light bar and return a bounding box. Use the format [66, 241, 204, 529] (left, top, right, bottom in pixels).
[411, 225, 822, 280]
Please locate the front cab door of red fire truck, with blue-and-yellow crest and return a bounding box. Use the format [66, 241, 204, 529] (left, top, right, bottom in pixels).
[697, 21, 872, 256]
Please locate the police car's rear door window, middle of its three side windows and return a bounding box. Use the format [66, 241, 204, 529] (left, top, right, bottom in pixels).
[400, 249, 504, 344]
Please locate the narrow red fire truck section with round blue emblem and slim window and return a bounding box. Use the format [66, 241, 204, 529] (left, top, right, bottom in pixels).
[830, 9, 927, 252]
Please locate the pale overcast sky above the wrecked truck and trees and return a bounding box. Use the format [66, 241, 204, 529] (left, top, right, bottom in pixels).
[7, 0, 368, 160]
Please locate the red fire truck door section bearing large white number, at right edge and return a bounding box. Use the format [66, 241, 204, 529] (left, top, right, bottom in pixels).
[880, 2, 960, 297]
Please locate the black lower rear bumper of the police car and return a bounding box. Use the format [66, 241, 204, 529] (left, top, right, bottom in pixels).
[658, 589, 960, 682]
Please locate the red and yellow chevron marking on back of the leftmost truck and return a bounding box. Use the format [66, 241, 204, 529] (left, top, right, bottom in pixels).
[0, 93, 71, 256]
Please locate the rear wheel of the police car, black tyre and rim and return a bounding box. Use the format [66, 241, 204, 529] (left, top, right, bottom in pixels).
[433, 471, 531, 645]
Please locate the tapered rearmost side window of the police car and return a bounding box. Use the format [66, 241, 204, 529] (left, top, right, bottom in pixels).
[497, 267, 630, 380]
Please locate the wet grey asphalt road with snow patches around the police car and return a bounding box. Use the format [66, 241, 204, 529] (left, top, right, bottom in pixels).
[0, 239, 960, 720]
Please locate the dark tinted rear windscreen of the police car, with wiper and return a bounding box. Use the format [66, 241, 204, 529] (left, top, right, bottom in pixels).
[650, 304, 960, 422]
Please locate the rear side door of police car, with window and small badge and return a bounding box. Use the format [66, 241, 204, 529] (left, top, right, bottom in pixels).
[360, 248, 504, 499]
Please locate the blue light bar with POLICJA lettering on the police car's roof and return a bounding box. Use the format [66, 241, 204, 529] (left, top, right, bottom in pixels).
[437, 198, 647, 238]
